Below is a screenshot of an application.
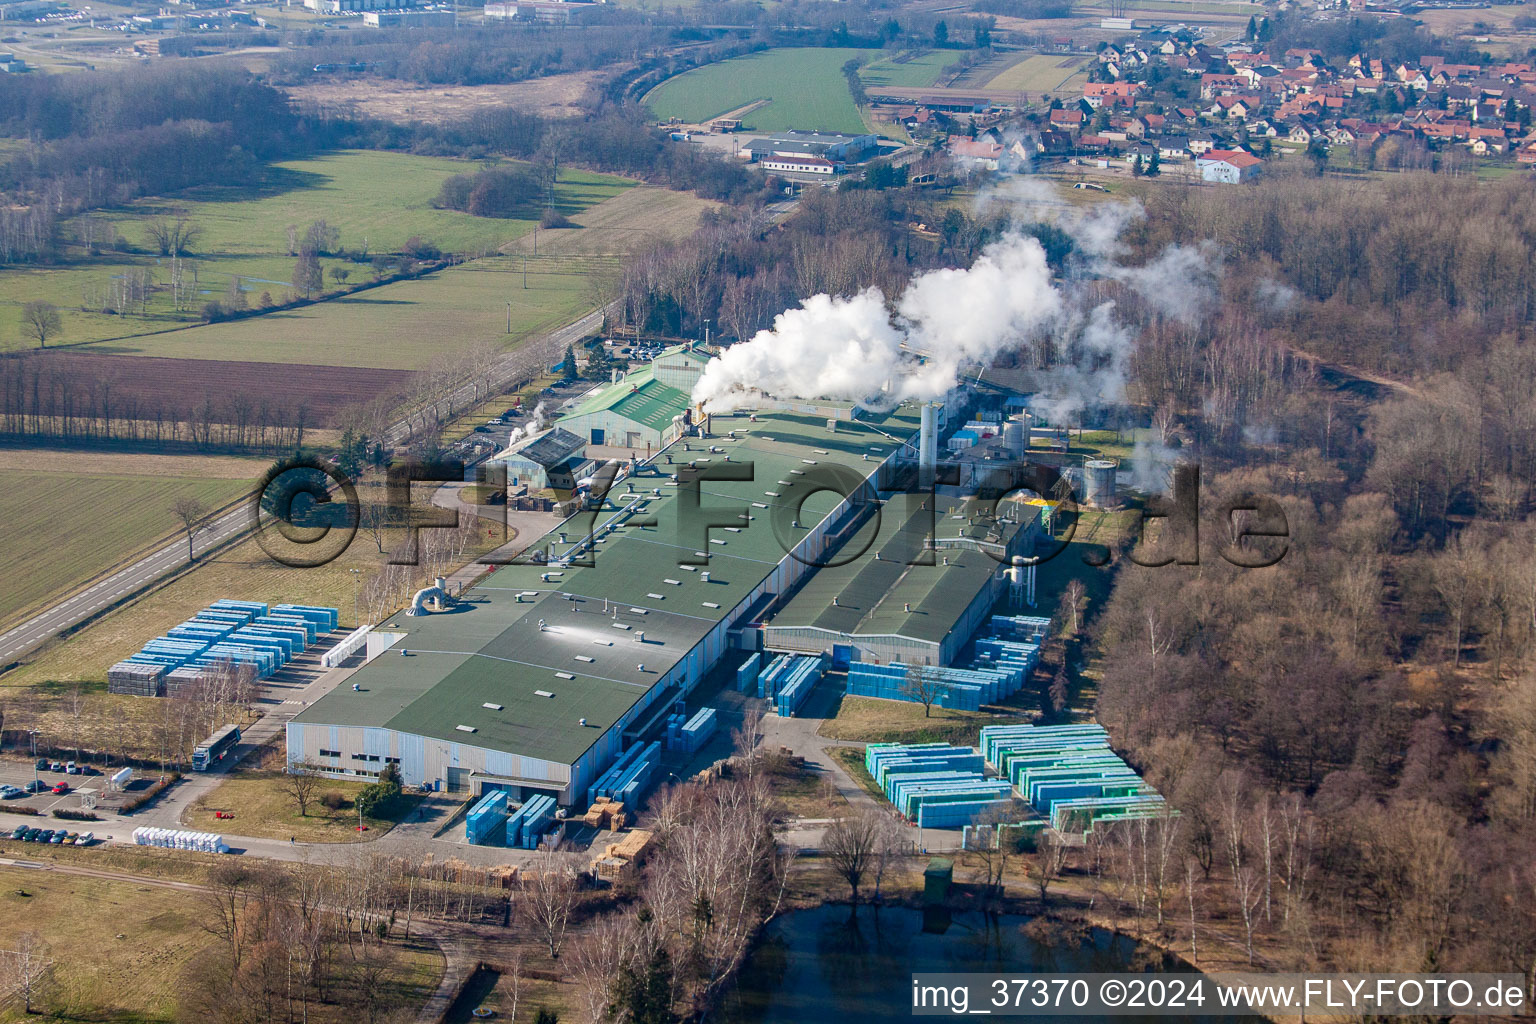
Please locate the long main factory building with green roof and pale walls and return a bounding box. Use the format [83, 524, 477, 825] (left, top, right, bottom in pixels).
[287, 407, 919, 806]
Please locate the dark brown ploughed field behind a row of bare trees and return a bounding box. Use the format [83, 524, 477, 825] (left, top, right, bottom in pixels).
[0, 352, 413, 427]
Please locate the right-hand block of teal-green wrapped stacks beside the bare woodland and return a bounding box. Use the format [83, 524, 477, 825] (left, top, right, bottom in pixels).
[982, 725, 1169, 832]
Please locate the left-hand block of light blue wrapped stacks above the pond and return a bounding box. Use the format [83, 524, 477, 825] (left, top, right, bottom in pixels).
[865, 743, 1014, 829]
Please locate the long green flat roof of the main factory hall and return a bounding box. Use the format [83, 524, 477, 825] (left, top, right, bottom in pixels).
[293, 408, 917, 765]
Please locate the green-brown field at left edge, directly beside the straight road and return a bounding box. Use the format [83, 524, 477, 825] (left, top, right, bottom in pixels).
[0, 469, 260, 622]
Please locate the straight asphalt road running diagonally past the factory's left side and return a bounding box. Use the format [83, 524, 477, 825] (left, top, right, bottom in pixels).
[0, 303, 602, 669]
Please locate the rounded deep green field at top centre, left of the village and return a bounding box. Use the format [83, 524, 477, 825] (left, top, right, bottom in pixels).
[645, 46, 868, 132]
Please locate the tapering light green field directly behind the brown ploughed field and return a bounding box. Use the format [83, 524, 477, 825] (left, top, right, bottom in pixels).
[84, 255, 611, 370]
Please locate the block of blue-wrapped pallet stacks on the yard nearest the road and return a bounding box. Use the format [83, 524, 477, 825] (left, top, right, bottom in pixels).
[108, 599, 336, 697]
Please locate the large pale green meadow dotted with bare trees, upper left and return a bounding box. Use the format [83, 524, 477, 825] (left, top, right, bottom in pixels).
[0, 150, 633, 359]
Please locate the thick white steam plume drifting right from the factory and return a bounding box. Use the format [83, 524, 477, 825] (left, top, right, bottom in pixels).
[693, 178, 1220, 424]
